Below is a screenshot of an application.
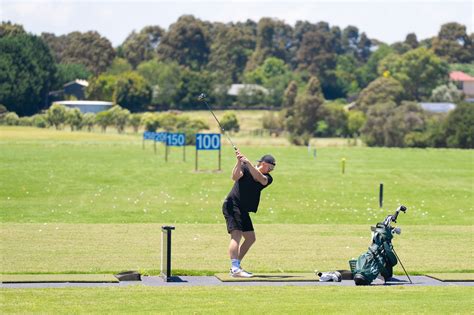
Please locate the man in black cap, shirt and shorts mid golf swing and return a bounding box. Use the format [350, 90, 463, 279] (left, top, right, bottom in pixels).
[222, 150, 276, 278]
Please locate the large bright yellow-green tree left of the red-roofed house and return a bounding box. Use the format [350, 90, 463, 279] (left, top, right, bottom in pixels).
[379, 47, 448, 100]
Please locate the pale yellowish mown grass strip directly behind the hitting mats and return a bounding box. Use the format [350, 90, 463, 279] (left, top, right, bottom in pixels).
[0, 225, 474, 275]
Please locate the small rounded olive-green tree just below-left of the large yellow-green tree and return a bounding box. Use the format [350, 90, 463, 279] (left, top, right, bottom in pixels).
[356, 77, 403, 113]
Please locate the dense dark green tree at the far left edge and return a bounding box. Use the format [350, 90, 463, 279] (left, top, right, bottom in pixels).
[0, 34, 56, 116]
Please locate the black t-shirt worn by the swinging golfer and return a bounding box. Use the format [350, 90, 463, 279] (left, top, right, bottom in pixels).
[227, 164, 273, 212]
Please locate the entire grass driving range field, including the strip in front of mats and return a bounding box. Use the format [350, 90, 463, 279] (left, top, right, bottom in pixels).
[0, 126, 474, 313]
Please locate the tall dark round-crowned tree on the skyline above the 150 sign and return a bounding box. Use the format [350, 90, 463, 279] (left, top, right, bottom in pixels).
[158, 15, 210, 70]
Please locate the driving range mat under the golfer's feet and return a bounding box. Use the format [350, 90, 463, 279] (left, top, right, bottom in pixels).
[214, 273, 319, 282]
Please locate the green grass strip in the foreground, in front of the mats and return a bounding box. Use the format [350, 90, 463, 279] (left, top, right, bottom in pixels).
[0, 286, 474, 314]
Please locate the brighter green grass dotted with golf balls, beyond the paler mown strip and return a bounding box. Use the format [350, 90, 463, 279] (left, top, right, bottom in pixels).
[0, 127, 474, 225]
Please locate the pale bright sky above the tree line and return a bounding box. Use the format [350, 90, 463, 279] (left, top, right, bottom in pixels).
[0, 0, 474, 46]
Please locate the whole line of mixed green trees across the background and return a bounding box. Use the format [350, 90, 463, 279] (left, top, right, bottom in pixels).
[0, 15, 474, 146]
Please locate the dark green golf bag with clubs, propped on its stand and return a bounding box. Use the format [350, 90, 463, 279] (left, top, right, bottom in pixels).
[354, 206, 407, 285]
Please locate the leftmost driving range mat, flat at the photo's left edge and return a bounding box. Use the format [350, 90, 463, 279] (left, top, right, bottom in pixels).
[0, 274, 119, 283]
